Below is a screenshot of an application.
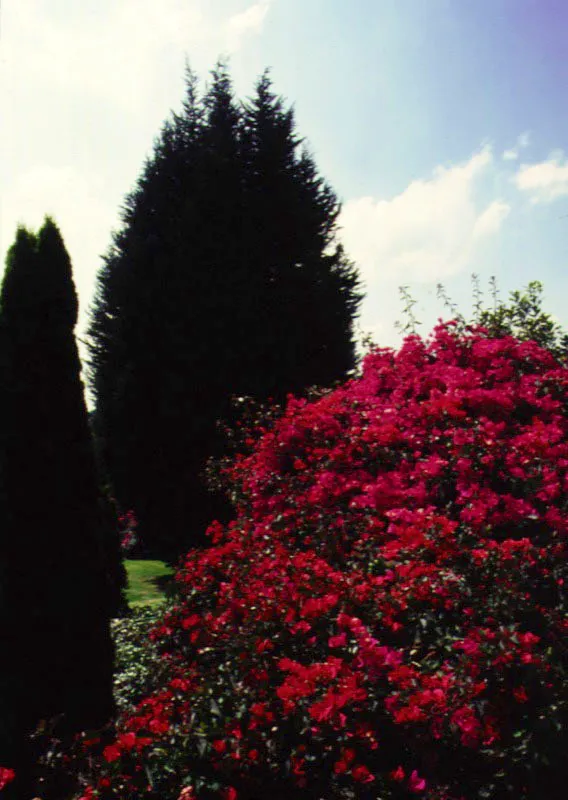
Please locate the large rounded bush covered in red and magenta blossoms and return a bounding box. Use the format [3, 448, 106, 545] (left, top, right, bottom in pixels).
[69, 323, 568, 800]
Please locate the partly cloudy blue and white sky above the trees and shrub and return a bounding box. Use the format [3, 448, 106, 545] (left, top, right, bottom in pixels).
[0, 0, 568, 366]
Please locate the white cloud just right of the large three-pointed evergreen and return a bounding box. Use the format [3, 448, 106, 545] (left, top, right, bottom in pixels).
[340, 147, 510, 290]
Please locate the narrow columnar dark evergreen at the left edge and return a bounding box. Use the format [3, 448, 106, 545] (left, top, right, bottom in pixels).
[0, 218, 118, 797]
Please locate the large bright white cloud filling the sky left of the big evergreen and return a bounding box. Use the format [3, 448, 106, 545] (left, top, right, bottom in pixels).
[0, 0, 276, 316]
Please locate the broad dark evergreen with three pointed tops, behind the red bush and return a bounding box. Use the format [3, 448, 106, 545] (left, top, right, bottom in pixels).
[90, 64, 360, 554]
